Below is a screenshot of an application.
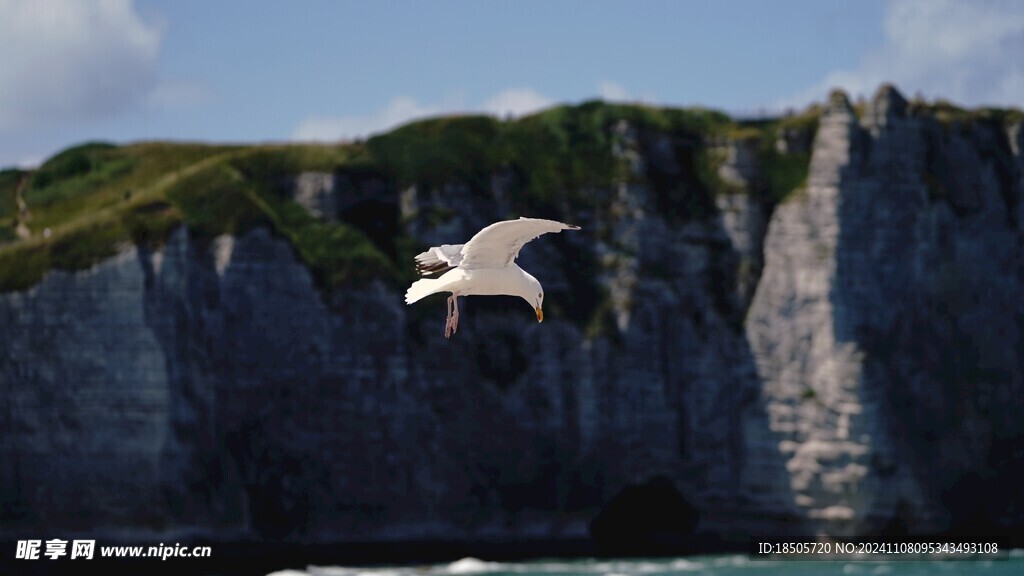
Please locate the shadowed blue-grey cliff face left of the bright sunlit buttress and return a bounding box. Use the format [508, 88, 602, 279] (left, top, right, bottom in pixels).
[0, 162, 785, 541]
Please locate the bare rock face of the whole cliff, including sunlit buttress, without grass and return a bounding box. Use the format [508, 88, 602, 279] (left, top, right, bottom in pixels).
[0, 88, 1024, 541]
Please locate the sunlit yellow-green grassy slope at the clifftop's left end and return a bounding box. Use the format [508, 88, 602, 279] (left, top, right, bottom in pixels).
[0, 142, 395, 291]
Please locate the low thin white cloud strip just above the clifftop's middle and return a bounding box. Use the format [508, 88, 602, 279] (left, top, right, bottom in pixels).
[292, 88, 554, 141]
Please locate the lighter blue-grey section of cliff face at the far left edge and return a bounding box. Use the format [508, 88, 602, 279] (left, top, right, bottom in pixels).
[0, 252, 175, 531]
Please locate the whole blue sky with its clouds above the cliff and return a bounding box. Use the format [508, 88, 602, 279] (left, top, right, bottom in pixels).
[0, 0, 1024, 166]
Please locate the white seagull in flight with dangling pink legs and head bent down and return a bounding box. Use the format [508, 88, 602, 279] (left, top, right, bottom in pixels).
[406, 218, 580, 338]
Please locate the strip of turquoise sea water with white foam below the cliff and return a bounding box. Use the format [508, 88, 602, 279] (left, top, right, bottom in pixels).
[271, 550, 1024, 576]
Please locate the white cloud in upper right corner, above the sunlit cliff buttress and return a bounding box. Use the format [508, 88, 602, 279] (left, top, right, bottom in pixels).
[780, 0, 1024, 107]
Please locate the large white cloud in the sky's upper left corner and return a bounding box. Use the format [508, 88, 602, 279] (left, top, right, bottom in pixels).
[0, 0, 161, 131]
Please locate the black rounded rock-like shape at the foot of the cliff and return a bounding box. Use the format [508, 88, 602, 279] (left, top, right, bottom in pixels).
[590, 477, 699, 556]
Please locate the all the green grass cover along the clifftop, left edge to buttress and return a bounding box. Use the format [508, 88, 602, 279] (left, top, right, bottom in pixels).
[0, 101, 816, 291]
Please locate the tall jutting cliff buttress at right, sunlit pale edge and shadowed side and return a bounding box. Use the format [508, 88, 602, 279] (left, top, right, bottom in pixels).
[746, 88, 1024, 536]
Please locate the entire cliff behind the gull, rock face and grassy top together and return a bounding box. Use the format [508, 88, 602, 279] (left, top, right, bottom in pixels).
[0, 86, 1024, 562]
